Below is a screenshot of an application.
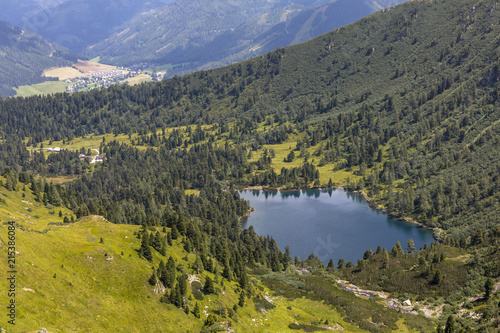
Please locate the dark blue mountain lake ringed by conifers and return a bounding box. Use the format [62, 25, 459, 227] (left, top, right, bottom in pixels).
[240, 190, 434, 264]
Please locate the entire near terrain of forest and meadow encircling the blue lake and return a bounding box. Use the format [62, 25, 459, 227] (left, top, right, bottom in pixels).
[0, 0, 500, 333]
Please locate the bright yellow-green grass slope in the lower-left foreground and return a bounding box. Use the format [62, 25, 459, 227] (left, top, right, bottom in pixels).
[0, 177, 378, 333]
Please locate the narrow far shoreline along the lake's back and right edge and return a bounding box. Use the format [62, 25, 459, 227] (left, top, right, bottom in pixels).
[238, 186, 441, 242]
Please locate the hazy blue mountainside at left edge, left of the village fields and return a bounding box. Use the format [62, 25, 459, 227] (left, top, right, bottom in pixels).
[0, 21, 77, 97]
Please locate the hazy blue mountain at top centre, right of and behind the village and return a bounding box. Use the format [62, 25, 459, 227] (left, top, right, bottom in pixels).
[86, 0, 405, 75]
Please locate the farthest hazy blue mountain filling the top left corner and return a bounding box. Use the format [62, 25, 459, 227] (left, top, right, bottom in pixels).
[0, 0, 172, 52]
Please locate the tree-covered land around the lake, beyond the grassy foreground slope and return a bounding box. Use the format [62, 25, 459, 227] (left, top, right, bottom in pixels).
[0, 0, 500, 332]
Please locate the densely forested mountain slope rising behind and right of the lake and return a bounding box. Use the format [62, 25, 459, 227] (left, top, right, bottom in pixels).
[1, 1, 500, 239]
